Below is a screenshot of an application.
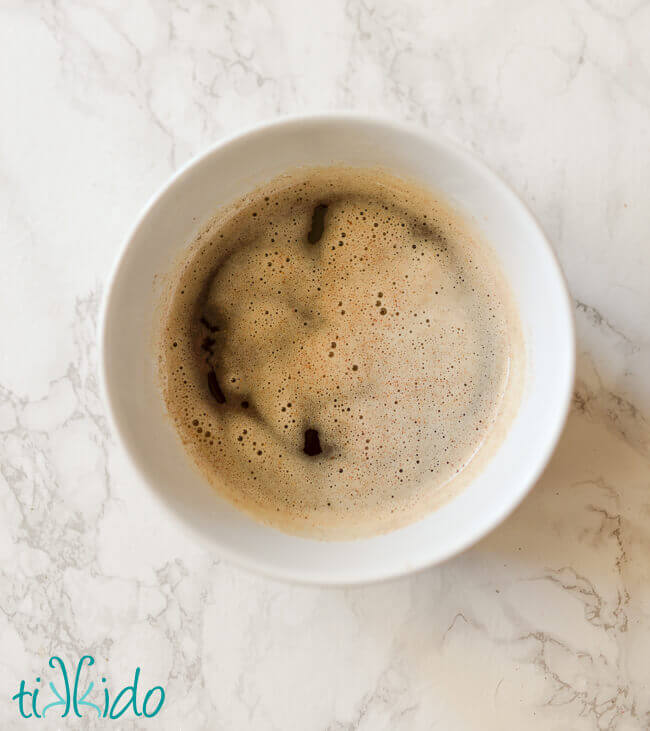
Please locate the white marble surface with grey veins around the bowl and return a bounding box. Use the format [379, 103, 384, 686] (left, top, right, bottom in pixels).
[0, 0, 650, 731]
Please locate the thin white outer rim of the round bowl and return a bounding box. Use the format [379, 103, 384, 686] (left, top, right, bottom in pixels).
[97, 111, 576, 586]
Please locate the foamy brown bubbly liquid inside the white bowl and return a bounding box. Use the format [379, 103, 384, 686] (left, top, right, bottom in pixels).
[159, 167, 523, 539]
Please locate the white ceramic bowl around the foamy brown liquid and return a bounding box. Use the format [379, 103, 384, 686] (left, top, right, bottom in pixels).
[100, 114, 575, 585]
